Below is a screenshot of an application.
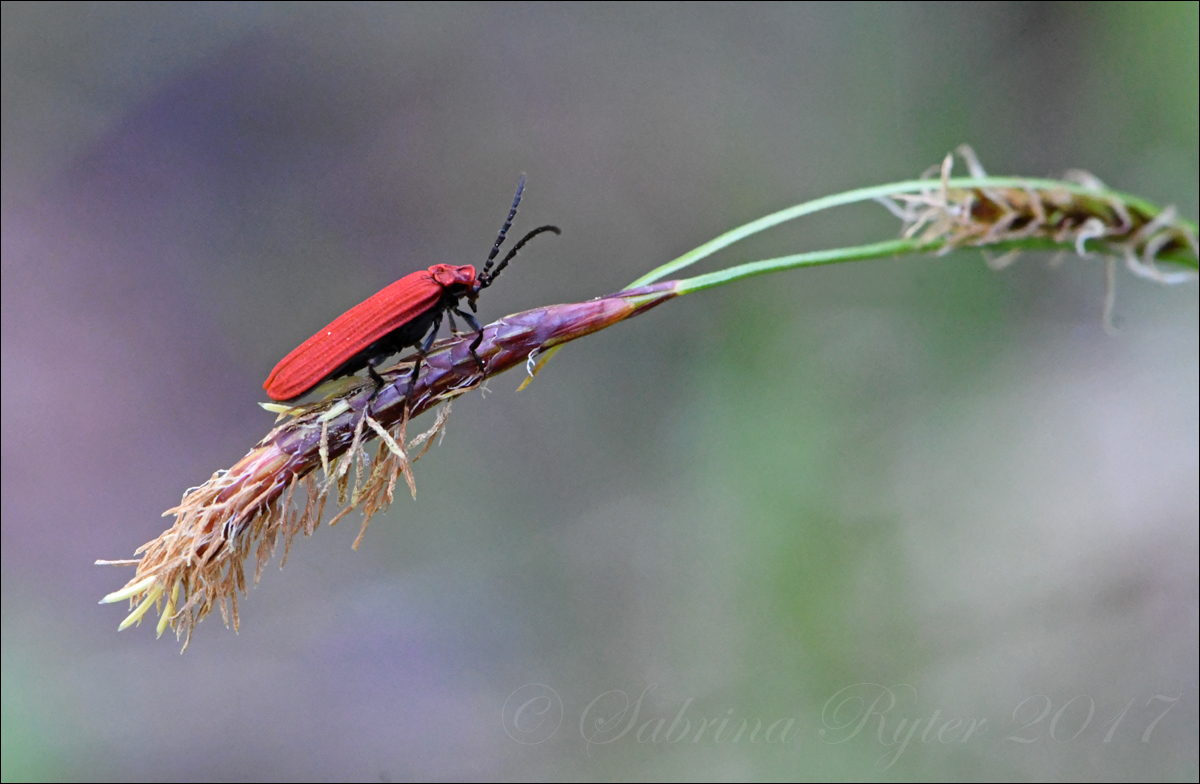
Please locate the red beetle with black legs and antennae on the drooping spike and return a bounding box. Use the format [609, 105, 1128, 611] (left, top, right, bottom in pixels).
[263, 176, 562, 400]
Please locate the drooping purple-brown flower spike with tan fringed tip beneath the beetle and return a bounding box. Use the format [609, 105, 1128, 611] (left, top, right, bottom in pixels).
[97, 282, 677, 650]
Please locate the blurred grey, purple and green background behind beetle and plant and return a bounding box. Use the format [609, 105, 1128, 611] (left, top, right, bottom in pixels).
[0, 2, 1200, 780]
